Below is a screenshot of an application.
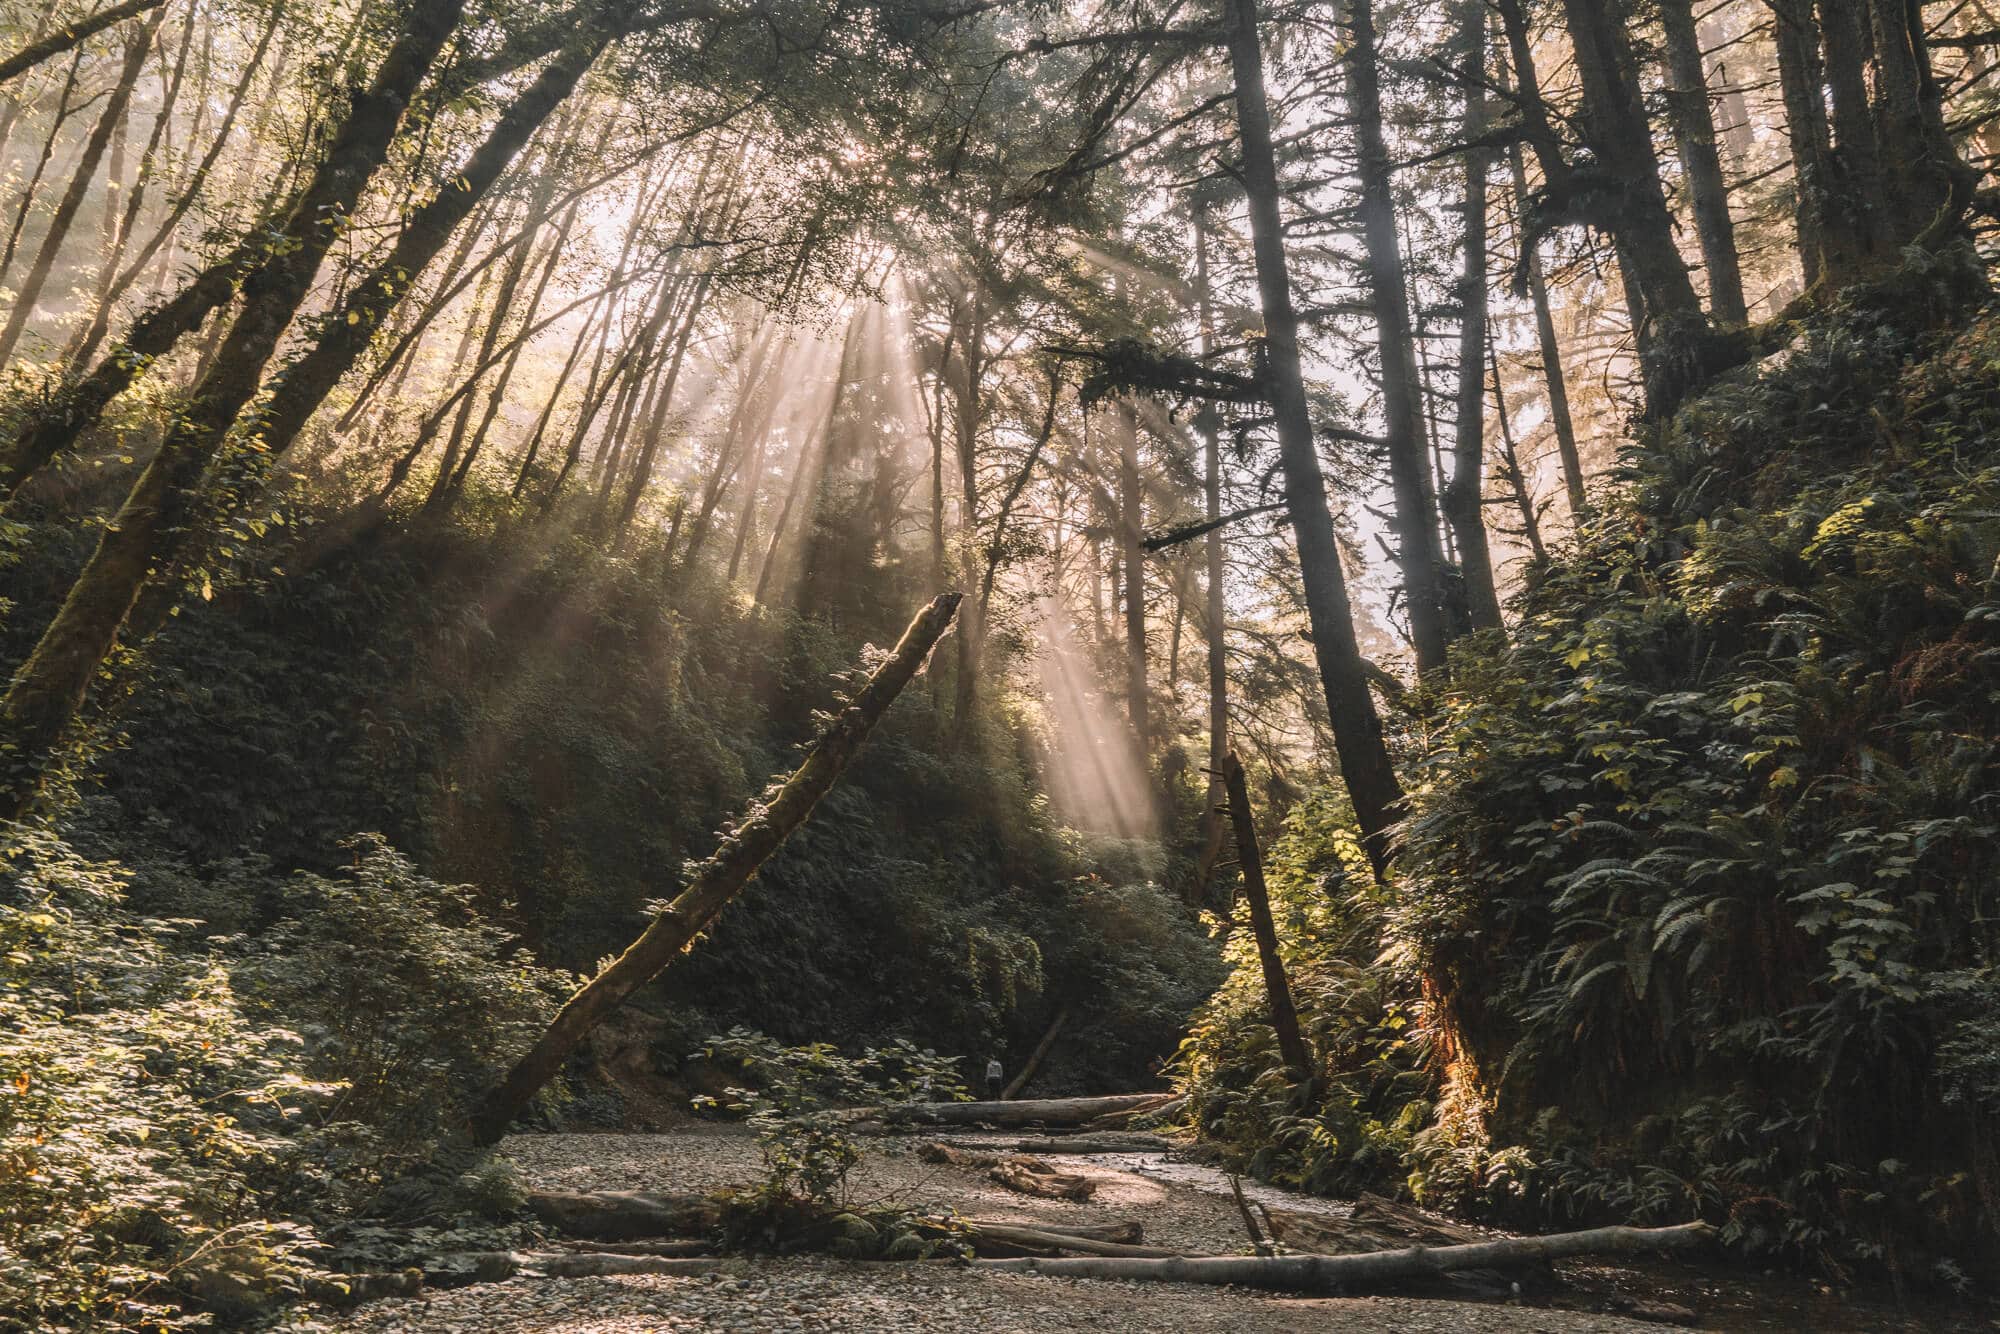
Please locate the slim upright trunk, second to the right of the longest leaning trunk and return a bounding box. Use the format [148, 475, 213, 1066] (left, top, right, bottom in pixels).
[1444, 0, 1500, 630]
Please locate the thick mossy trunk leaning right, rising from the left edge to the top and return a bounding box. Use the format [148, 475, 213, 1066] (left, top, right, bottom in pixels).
[0, 0, 464, 818]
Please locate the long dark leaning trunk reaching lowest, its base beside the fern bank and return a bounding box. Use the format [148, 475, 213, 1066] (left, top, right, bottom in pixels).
[1224, 0, 1402, 874]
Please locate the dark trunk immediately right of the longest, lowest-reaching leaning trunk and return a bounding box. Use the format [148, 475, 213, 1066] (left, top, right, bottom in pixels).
[1344, 0, 1450, 674]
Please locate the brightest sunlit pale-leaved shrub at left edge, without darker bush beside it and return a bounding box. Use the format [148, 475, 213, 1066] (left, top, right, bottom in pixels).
[0, 834, 334, 1330]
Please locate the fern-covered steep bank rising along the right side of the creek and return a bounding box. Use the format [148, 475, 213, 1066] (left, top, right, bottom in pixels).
[1182, 288, 2000, 1286]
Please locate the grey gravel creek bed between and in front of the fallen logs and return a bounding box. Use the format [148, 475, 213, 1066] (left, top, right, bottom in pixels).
[332, 1126, 1992, 1334]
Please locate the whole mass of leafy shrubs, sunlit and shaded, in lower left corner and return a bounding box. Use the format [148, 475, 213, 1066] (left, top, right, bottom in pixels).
[0, 830, 564, 1330]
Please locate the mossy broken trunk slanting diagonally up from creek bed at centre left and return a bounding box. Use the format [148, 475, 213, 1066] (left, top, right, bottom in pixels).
[472, 592, 962, 1144]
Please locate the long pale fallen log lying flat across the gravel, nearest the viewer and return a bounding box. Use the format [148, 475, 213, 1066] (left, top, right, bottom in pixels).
[974, 1222, 1716, 1292]
